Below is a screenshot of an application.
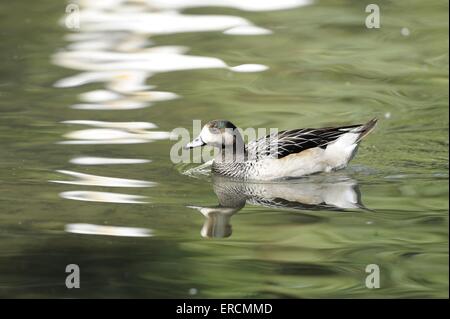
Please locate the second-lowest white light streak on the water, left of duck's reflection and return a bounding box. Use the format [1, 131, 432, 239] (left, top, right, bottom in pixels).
[59, 191, 148, 204]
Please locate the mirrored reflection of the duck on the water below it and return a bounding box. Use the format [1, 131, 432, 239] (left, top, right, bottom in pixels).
[188, 175, 364, 238]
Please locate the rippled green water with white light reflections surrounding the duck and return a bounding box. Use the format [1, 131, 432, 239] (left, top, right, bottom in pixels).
[0, 0, 449, 298]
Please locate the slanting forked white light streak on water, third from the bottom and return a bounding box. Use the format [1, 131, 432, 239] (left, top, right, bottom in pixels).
[50, 170, 156, 187]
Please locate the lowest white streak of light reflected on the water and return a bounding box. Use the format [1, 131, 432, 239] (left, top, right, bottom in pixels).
[65, 224, 153, 237]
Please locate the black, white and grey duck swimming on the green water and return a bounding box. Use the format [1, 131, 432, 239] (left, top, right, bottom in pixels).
[185, 118, 378, 181]
